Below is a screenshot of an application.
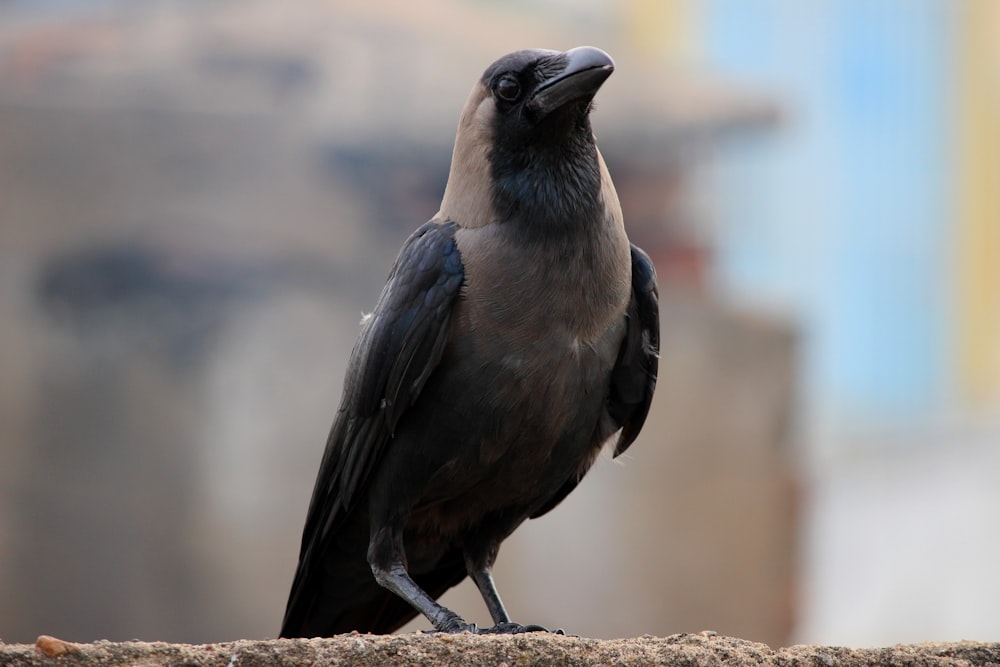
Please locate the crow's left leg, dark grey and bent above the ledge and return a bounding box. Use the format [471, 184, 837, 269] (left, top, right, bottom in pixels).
[368, 530, 477, 633]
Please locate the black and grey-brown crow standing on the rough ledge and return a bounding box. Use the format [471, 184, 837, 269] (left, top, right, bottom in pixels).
[281, 47, 659, 637]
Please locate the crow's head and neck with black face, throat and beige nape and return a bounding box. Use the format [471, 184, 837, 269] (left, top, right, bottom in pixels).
[438, 46, 614, 227]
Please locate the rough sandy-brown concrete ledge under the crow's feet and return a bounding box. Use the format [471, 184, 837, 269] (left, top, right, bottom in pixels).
[0, 632, 1000, 667]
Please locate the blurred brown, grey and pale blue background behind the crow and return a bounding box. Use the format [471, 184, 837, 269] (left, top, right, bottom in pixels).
[0, 0, 1000, 646]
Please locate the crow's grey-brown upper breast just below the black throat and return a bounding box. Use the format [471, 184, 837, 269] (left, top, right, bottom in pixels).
[454, 225, 631, 408]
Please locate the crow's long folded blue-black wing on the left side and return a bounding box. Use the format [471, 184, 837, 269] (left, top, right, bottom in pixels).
[281, 222, 464, 637]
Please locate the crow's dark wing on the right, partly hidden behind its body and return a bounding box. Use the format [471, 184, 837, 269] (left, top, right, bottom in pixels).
[531, 245, 660, 519]
